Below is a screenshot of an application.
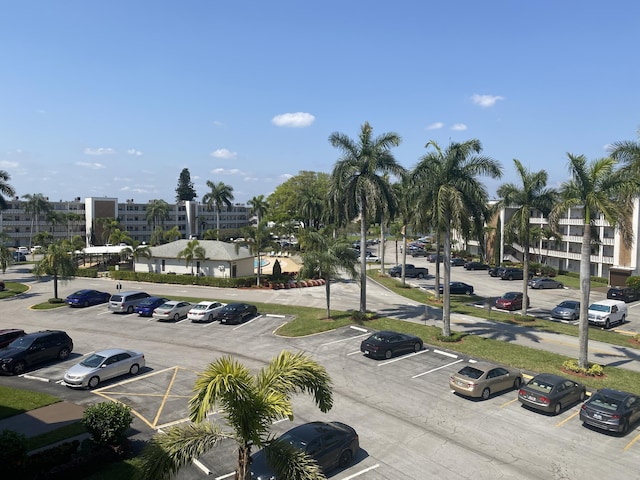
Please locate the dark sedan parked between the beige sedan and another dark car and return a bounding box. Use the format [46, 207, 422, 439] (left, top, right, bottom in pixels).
[518, 373, 587, 415]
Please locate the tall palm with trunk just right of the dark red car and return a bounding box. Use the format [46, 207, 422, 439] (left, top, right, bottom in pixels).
[497, 158, 557, 315]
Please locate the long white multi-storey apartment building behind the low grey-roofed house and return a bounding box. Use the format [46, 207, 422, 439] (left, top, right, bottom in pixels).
[0, 197, 250, 247]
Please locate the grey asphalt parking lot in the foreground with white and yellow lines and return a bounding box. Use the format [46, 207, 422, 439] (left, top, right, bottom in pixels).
[0, 268, 640, 480]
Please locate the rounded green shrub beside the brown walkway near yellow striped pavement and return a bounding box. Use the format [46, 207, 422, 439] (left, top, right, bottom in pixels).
[82, 402, 133, 445]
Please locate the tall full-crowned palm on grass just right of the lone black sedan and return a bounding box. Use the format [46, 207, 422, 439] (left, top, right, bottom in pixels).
[413, 139, 502, 337]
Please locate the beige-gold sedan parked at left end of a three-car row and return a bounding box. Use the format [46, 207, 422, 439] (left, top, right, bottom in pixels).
[449, 362, 522, 400]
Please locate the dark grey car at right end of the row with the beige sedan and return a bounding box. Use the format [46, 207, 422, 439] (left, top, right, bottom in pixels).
[580, 388, 640, 434]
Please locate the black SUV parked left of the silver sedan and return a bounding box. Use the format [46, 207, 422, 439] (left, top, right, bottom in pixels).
[0, 330, 73, 375]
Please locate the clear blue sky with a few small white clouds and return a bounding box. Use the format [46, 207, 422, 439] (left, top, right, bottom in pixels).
[0, 0, 640, 203]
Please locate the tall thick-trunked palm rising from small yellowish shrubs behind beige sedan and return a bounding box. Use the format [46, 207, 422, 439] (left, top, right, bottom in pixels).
[549, 153, 637, 368]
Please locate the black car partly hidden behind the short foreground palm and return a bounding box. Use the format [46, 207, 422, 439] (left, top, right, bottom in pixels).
[251, 422, 360, 480]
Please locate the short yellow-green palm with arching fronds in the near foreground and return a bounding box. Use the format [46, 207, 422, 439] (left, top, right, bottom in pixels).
[140, 351, 333, 480]
